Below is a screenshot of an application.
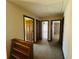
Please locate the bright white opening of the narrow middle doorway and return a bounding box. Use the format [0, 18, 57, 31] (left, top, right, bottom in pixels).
[42, 21, 48, 40]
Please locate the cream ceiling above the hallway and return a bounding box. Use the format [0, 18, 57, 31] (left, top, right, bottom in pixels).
[9, 0, 68, 17]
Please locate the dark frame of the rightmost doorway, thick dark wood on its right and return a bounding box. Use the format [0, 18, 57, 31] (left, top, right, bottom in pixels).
[50, 18, 64, 47]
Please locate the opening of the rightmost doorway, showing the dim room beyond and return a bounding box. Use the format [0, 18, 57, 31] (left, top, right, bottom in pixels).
[52, 21, 60, 41]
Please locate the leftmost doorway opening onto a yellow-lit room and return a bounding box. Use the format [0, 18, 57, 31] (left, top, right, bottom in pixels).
[23, 16, 34, 41]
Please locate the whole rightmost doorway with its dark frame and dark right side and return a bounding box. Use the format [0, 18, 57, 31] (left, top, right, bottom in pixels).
[51, 18, 64, 47]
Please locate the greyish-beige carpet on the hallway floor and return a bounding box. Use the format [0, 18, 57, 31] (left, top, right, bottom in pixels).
[33, 40, 63, 59]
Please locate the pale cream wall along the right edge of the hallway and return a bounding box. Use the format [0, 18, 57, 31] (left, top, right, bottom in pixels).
[63, 0, 72, 59]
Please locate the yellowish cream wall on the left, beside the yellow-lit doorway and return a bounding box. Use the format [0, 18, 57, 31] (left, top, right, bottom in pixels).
[6, 1, 36, 59]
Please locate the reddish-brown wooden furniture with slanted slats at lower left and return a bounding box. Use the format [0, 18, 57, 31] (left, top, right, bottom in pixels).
[10, 39, 33, 59]
